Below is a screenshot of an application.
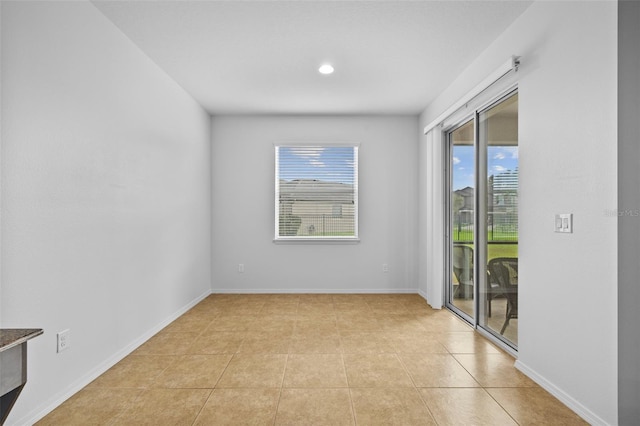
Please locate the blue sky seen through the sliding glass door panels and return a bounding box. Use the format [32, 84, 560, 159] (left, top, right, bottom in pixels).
[452, 145, 518, 191]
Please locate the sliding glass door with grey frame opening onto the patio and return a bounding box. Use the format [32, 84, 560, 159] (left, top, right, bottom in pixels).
[445, 92, 519, 348]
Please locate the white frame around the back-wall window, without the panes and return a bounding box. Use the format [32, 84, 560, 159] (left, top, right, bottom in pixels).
[273, 142, 360, 244]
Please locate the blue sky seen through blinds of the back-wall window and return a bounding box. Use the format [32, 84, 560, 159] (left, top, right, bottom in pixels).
[279, 146, 355, 184]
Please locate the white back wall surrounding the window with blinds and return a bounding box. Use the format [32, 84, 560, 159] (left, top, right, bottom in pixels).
[212, 116, 418, 292]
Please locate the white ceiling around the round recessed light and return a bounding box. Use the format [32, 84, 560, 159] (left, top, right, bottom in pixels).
[93, 0, 531, 114]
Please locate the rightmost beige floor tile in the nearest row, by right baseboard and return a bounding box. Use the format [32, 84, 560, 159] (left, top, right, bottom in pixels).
[487, 387, 588, 426]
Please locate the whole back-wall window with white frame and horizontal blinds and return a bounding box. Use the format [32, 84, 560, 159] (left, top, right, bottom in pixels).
[275, 144, 358, 241]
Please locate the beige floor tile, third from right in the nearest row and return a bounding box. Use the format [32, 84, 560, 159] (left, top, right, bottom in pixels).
[351, 388, 436, 426]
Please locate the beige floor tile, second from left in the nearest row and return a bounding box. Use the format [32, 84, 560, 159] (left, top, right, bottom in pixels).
[113, 389, 211, 426]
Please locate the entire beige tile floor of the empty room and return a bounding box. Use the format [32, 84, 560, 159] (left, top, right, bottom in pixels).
[38, 294, 586, 426]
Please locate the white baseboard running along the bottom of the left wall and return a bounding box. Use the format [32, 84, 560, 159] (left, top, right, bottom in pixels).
[18, 290, 211, 425]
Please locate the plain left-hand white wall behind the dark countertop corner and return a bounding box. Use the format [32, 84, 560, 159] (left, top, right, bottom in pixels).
[1, 2, 211, 424]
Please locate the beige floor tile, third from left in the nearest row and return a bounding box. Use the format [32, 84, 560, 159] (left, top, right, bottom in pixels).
[194, 389, 280, 426]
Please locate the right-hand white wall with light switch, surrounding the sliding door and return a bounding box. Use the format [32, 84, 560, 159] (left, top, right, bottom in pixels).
[421, 1, 617, 424]
